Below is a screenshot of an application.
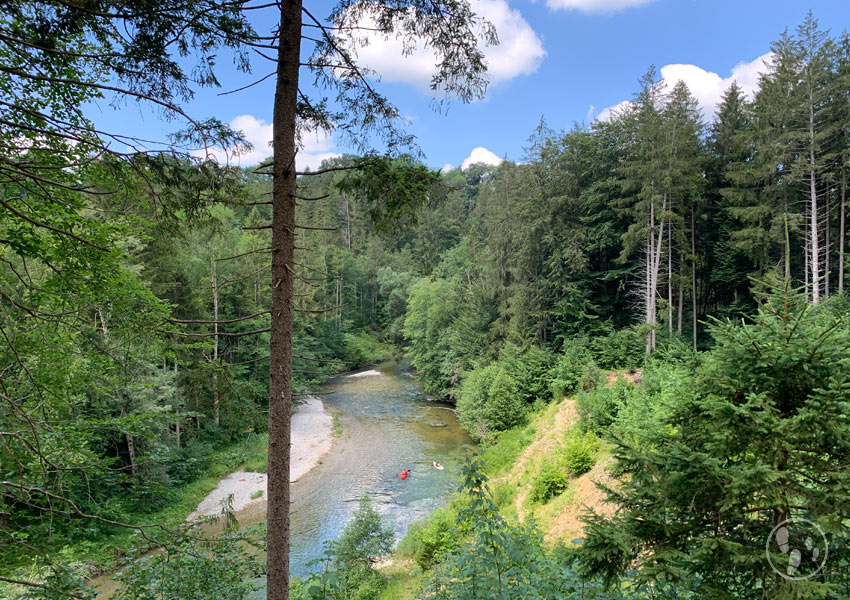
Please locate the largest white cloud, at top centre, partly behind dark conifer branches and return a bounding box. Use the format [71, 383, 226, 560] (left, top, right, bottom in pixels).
[347, 0, 546, 94]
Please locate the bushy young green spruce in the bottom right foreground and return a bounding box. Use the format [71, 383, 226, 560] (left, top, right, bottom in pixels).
[582, 282, 850, 600]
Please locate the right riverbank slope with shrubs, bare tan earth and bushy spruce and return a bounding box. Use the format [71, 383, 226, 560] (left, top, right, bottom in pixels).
[362, 285, 850, 600]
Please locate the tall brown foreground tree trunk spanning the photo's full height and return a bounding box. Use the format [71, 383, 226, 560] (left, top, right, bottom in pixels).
[266, 0, 301, 600]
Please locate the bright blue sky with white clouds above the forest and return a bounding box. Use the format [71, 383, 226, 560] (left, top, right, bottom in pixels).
[86, 0, 850, 173]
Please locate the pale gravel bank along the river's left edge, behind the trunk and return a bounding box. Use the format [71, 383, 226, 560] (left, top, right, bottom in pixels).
[186, 398, 333, 521]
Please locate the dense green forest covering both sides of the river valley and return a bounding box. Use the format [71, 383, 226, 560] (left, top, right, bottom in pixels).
[0, 4, 850, 598]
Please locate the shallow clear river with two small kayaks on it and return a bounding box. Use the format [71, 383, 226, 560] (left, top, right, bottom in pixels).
[96, 362, 472, 598]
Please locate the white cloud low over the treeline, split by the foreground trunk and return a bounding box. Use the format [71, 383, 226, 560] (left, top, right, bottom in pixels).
[192, 115, 339, 170]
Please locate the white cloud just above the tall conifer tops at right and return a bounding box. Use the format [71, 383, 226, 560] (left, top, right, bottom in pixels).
[596, 52, 772, 121]
